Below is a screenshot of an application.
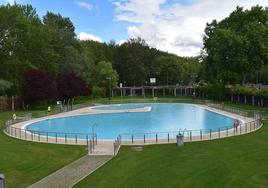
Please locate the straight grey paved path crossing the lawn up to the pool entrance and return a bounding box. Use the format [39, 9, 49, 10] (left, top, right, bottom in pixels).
[29, 155, 112, 188]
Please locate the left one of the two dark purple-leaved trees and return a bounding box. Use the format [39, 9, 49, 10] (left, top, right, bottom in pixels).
[22, 69, 58, 101]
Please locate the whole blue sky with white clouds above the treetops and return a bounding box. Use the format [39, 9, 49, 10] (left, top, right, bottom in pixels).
[0, 0, 268, 56]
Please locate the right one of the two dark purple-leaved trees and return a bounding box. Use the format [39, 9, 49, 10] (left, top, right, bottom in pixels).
[58, 74, 89, 99]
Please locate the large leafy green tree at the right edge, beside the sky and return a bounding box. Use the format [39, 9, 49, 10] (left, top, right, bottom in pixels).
[203, 6, 268, 84]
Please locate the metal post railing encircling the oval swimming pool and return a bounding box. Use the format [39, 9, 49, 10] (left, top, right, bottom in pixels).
[4, 99, 262, 154]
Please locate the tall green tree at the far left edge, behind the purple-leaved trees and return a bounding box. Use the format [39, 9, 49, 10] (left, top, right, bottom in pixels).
[0, 4, 57, 94]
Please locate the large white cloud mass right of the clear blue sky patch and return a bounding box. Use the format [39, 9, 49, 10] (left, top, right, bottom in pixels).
[112, 0, 267, 56]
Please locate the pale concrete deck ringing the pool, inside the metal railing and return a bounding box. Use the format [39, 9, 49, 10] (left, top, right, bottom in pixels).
[4, 103, 260, 155]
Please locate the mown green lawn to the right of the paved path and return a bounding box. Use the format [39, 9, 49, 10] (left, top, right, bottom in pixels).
[76, 121, 268, 188]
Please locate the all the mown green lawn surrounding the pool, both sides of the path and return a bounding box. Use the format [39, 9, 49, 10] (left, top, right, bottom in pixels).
[0, 97, 268, 187]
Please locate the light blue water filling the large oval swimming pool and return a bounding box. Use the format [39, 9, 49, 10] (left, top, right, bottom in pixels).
[27, 103, 233, 139]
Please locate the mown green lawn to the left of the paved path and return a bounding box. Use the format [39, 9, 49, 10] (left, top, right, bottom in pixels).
[0, 112, 86, 188]
